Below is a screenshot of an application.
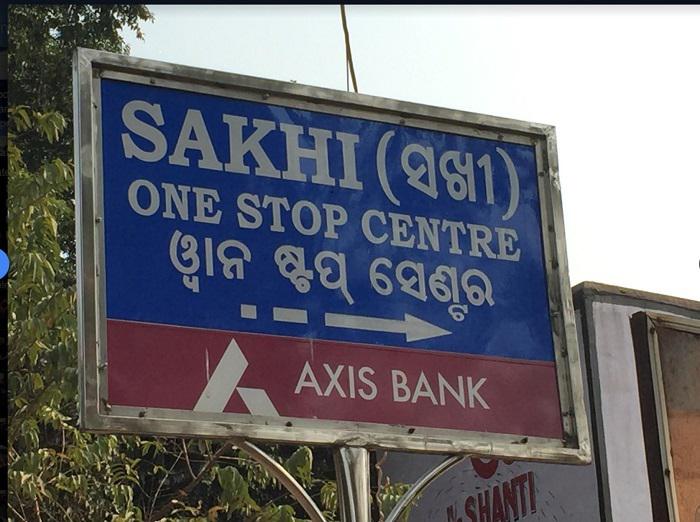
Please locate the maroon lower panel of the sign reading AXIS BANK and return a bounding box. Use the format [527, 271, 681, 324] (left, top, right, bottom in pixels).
[107, 320, 561, 438]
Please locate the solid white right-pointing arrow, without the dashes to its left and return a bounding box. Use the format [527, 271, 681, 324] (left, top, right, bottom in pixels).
[326, 313, 452, 343]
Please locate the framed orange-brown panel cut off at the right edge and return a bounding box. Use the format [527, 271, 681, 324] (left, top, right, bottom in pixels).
[632, 312, 700, 522]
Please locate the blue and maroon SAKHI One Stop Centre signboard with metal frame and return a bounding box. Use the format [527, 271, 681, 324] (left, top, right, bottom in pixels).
[75, 50, 589, 462]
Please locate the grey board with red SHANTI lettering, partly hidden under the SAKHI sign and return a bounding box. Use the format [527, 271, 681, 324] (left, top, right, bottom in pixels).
[383, 453, 601, 522]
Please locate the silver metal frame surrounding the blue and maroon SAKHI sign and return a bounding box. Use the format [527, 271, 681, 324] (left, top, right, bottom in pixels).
[73, 49, 591, 463]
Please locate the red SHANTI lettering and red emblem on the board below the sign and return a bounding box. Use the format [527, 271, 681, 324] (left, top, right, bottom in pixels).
[446, 458, 537, 522]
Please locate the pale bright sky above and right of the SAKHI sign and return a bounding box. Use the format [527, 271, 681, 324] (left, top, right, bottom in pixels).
[124, 5, 700, 300]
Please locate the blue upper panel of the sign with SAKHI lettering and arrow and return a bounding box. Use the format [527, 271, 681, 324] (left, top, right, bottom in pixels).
[101, 79, 554, 362]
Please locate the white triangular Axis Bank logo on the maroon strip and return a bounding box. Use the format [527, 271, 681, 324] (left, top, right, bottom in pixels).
[194, 337, 279, 417]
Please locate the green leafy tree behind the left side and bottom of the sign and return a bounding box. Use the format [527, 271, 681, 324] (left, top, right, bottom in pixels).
[8, 5, 416, 522]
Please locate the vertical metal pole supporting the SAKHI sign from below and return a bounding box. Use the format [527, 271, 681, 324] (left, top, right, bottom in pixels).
[333, 447, 371, 522]
